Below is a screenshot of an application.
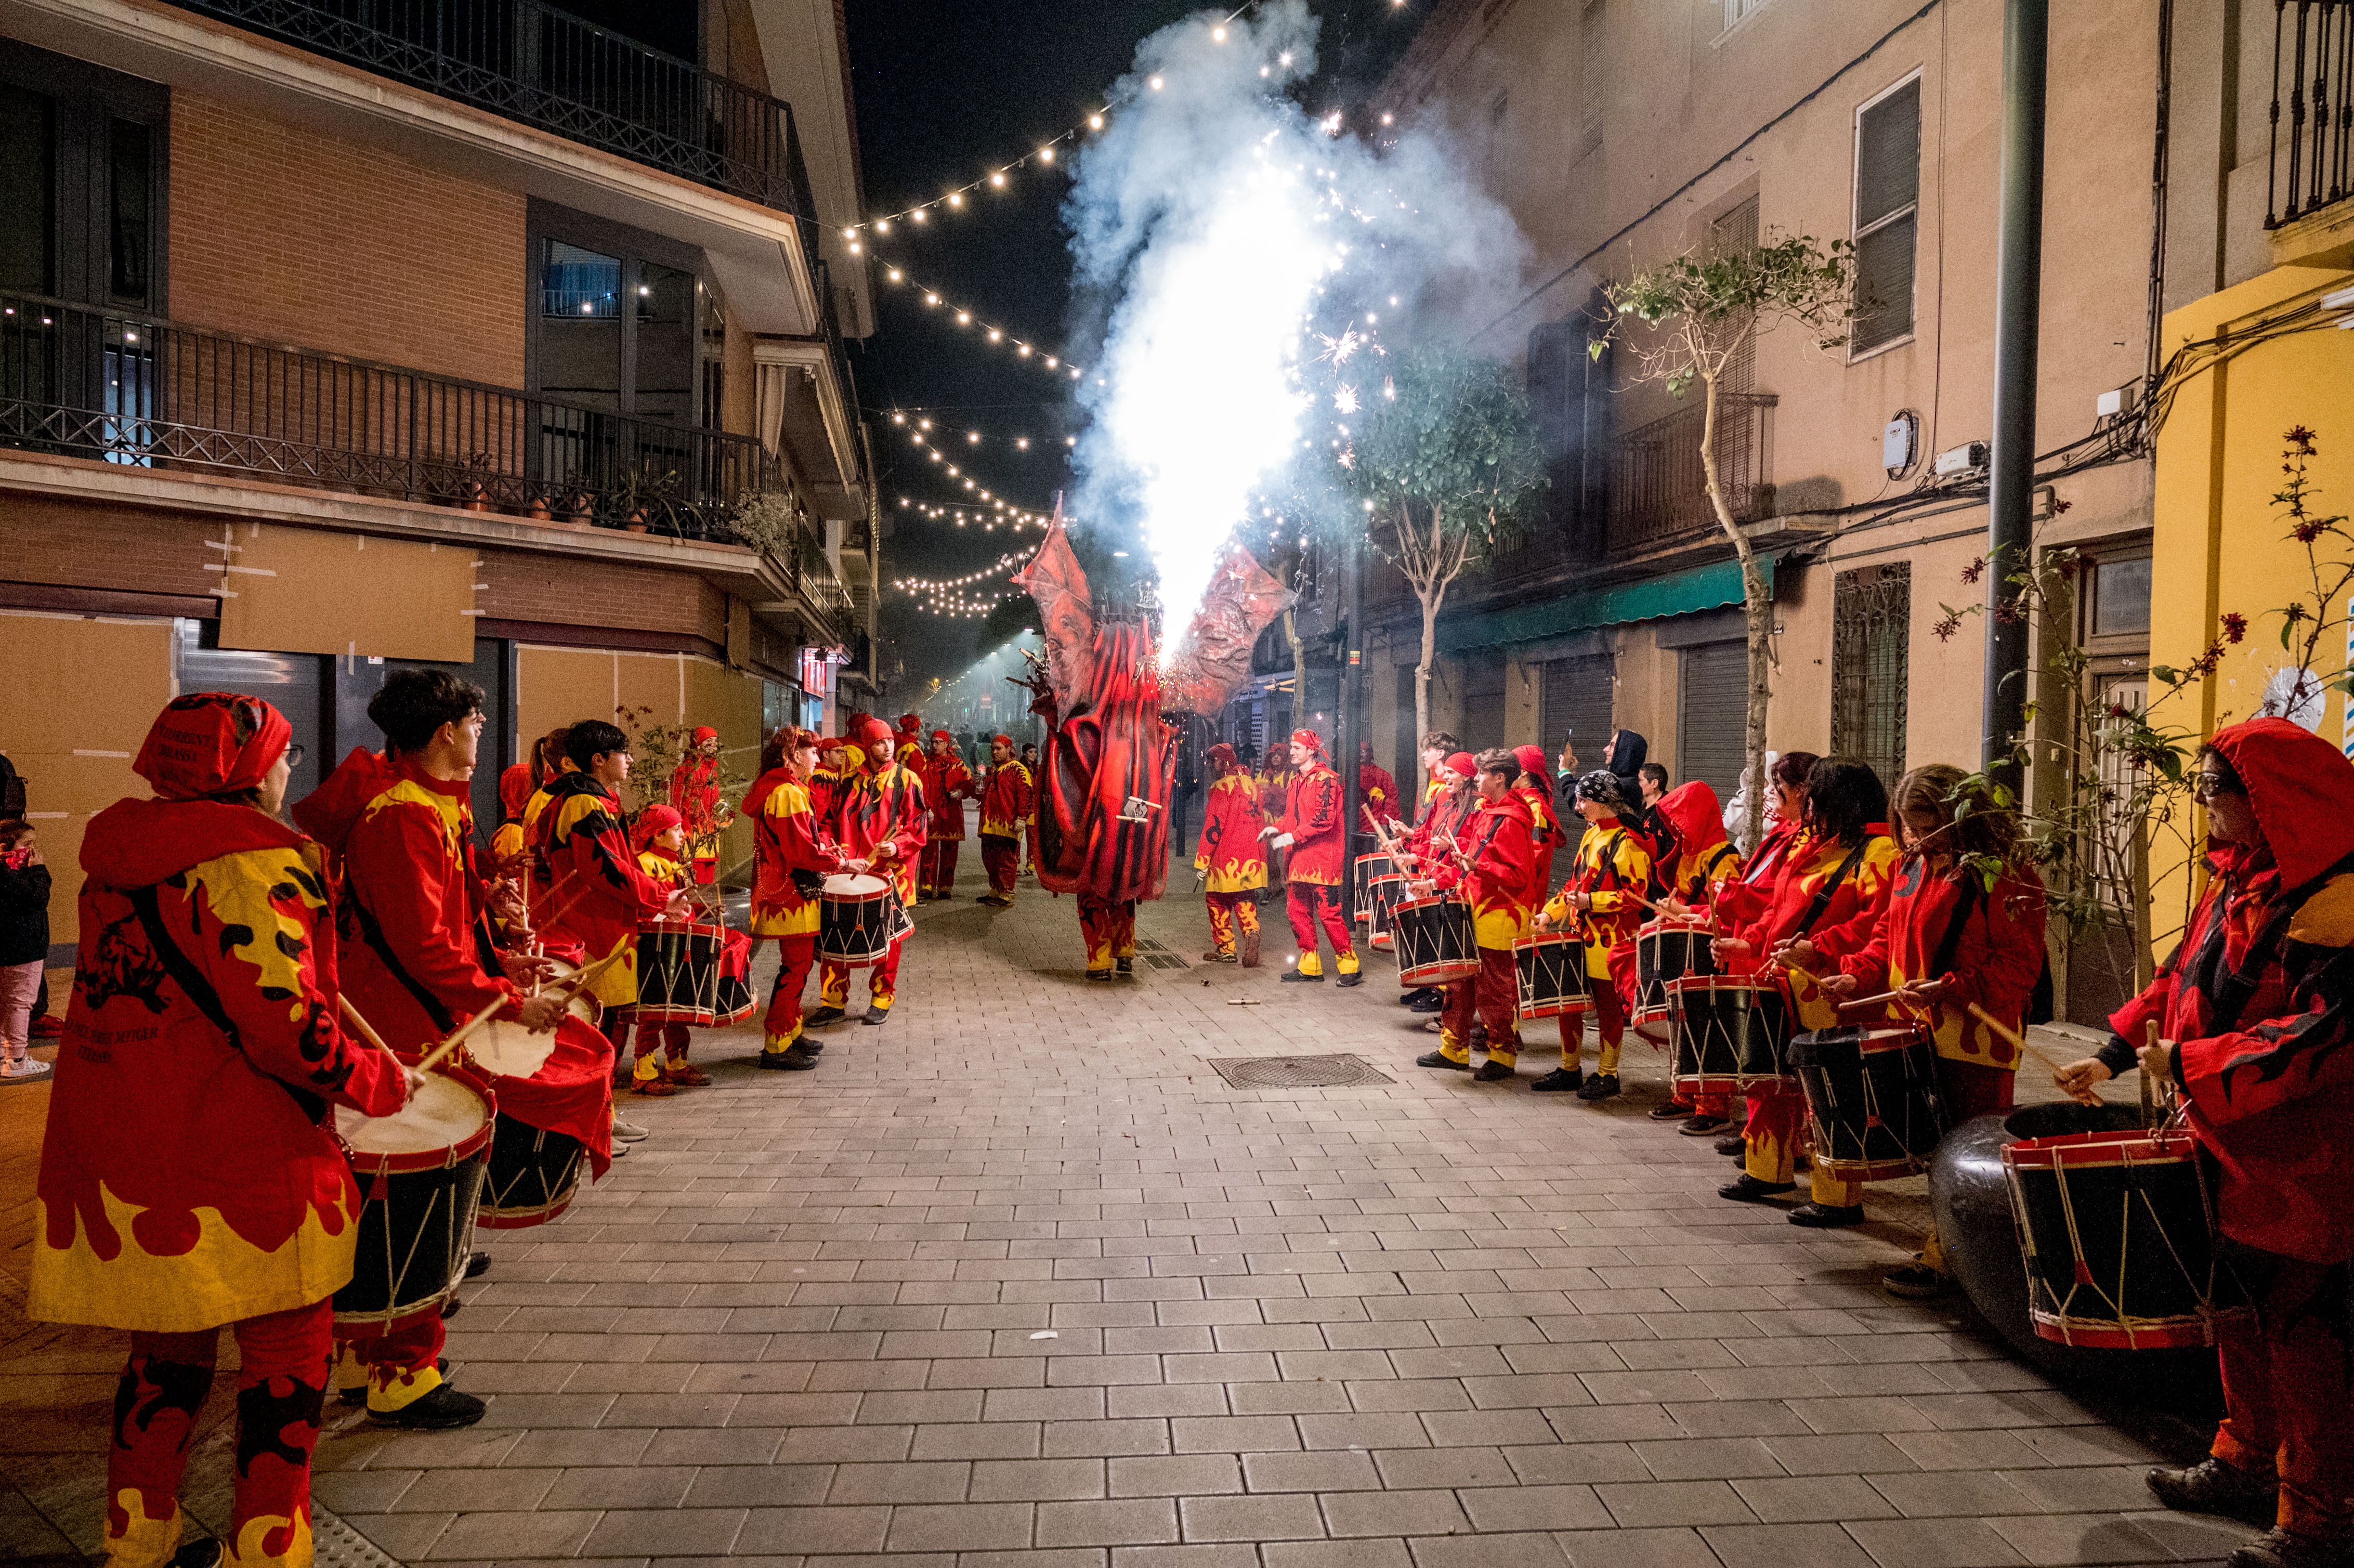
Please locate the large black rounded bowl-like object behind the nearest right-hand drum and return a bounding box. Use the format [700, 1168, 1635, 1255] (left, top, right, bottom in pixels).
[1928, 1100, 2222, 1415]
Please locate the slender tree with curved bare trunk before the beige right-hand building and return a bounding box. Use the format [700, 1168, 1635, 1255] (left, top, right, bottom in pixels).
[1589, 236, 1855, 843]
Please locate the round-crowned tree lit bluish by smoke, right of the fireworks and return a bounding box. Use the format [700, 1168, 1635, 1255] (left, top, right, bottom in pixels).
[1302, 348, 1547, 753]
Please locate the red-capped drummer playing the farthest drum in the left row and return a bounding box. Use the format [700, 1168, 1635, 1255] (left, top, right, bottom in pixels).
[744, 727, 866, 1074]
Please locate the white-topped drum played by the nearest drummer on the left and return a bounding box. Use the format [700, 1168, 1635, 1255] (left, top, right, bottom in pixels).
[334, 1071, 494, 1323]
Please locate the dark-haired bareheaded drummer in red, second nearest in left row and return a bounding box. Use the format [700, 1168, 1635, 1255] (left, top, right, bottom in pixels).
[294, 669, 593, 1427]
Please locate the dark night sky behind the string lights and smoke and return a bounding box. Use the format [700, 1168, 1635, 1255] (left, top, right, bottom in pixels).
[847, 0, 1431, 697]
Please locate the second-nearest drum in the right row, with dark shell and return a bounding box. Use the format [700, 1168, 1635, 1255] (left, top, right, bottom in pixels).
[1789, 1024, 1944, 1182]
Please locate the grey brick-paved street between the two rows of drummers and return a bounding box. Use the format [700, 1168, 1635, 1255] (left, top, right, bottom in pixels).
[0, 852, 2243, 1568]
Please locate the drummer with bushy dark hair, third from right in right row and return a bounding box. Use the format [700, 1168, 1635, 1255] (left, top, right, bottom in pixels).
[1716, 756, 1898, 1226]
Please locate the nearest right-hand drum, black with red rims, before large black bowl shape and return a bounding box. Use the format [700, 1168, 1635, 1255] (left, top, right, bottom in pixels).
[2003, 1130, 2246, 1349]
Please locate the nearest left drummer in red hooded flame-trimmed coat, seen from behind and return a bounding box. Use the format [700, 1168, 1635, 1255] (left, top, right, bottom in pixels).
[26, 692, 407, 1568]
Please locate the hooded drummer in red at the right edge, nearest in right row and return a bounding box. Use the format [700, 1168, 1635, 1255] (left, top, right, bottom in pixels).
[2055, 718, 2354, 1568]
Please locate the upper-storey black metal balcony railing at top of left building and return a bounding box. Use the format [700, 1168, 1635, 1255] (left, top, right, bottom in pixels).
[156, 0, 817, 226]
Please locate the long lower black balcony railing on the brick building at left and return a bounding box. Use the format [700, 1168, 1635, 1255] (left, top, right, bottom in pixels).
[0, 294, 772, 539]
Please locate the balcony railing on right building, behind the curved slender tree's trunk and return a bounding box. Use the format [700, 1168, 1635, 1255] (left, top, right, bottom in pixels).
[1610, 391, 1775, 556]
